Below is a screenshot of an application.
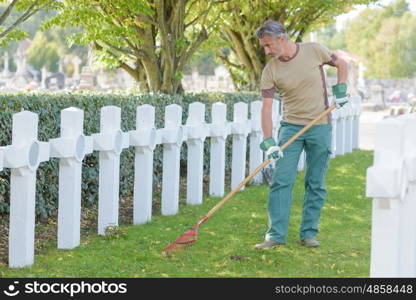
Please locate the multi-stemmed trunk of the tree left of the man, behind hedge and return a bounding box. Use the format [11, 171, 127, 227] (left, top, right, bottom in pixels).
[99, 0, 211, 94]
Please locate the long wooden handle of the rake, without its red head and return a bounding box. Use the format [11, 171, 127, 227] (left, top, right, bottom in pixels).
[204, 104, 336, 221]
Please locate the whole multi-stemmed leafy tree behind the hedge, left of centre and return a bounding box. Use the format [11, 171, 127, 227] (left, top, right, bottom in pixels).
[48, 0, 229, 94]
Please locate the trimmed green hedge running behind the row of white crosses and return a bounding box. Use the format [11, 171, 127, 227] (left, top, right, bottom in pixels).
[0, 92, 259, 217]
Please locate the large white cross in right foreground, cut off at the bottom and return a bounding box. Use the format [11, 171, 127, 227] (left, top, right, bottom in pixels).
[366, 119, 416, 277]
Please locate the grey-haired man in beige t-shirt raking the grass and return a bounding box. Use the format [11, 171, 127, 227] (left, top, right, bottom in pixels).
[255, 20, 348, 249]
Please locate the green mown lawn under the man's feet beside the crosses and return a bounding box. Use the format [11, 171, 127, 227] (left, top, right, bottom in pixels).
[0, 150, 373, 277]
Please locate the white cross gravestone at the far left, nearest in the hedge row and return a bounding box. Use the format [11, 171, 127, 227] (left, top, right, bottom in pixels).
[3, 111, 49, 268]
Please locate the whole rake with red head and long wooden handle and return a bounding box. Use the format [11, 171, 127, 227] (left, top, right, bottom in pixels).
[162, 104, 336, 256]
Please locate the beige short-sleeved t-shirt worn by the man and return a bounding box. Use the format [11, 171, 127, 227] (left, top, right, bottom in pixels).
[260, 43, 336, 125]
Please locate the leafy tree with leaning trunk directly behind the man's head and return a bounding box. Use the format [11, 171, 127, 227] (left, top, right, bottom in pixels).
[217, 0, 376, 90]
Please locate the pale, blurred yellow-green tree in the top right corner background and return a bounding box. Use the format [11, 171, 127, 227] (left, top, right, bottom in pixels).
[346, 0, 416, 78]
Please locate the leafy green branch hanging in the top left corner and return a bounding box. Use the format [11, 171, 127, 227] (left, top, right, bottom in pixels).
[0, 0, 58, 46]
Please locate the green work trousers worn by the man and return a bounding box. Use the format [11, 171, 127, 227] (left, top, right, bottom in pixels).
[266, 122, 332, 244]
